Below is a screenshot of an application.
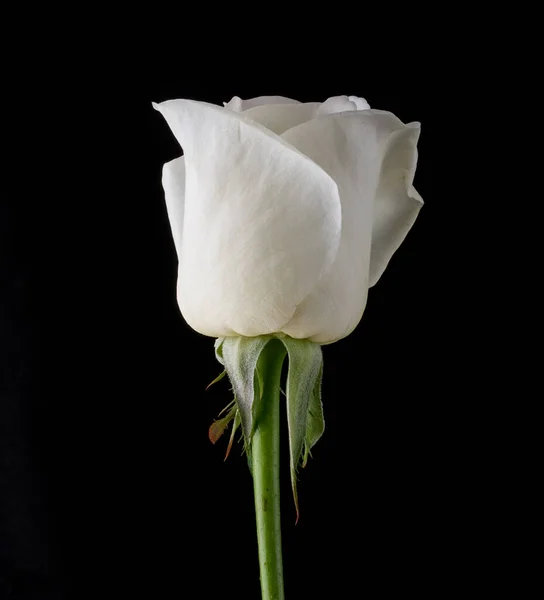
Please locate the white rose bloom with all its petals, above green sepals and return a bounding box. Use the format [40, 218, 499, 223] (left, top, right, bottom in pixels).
[154, 96, 423, 344]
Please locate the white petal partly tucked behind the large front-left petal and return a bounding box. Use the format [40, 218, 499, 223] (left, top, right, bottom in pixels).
[276, 110, 420, 343]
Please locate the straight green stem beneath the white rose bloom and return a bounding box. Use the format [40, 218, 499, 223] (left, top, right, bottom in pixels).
[251, 340, 286, 600]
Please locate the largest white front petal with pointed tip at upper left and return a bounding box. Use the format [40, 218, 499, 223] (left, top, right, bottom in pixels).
[156, 100, 341, 337]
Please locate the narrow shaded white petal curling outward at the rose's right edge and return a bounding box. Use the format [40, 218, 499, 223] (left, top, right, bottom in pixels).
[369, 123, 423, 286]
